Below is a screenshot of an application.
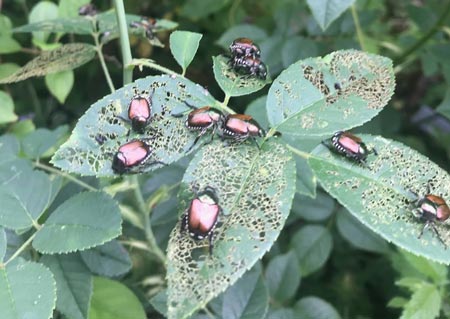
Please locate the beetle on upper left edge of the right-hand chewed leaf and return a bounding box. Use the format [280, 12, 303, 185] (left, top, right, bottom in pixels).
[322, 131, 378, 165]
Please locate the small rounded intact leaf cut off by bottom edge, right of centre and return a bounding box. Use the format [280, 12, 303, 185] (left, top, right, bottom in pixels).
[295, 296, 341, 319]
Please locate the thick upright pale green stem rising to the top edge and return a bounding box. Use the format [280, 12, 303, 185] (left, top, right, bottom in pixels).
[114, 0, 133, 85]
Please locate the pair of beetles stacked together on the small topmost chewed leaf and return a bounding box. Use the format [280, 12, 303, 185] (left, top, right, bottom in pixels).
[229, 38, 267, 80]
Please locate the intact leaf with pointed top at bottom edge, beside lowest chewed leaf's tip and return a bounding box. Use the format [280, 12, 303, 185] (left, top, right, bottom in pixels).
[222, 264, 269, 319]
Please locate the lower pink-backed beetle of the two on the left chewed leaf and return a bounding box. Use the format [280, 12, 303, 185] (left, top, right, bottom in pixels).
[112, 140, 165, 174]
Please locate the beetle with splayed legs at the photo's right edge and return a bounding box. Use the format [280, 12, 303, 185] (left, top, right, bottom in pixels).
[412, 185, 450, 249]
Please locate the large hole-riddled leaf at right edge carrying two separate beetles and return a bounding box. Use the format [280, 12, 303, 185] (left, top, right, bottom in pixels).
[309, 135, 450, 264]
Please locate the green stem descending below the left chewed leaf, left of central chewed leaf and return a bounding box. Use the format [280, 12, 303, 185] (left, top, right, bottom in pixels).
[129, 175, 166, 265]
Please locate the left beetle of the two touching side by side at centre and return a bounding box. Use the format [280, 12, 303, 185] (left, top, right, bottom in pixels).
[172, 102, 223, 152]
